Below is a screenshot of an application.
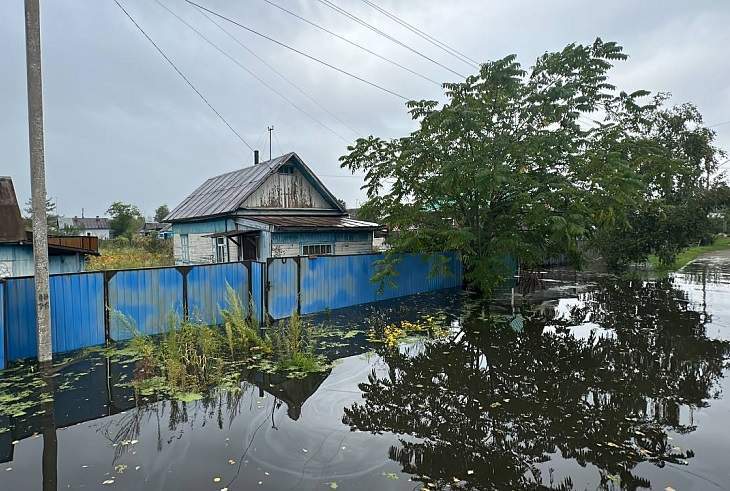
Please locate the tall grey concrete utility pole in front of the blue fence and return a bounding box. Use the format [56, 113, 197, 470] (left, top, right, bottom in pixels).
[25, 0, 53, 362]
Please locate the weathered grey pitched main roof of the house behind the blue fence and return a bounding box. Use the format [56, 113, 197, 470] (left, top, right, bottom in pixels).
[164, 152, 340, 222]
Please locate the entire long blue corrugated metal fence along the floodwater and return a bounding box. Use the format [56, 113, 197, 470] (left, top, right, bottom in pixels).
[0, 254, 462, 369]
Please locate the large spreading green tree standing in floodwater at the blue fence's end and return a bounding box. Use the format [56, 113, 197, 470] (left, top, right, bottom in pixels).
[340, 39, 646, 291]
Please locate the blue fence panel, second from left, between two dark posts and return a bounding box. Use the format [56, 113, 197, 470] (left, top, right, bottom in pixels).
[108, 268, 183, 341]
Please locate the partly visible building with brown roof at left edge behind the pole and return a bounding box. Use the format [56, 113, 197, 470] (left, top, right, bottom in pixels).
[0, 177, 99, 278]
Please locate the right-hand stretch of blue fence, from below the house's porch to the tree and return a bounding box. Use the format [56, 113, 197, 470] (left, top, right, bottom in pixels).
[267, 253, 462, 319]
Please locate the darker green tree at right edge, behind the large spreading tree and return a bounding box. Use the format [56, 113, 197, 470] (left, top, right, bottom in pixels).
[591, 99, 730, 269]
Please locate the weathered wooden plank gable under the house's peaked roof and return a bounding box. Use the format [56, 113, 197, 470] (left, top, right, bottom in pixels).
[241, 167, 335, 210]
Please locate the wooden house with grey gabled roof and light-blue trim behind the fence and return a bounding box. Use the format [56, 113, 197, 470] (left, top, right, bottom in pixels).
[165, 152, 379, 264]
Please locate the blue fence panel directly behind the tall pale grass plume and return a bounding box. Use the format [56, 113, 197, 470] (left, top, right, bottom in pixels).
[188, 263, 249, 325]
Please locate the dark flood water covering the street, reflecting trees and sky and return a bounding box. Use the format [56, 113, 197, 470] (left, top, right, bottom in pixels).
[0, 254, 730, 491]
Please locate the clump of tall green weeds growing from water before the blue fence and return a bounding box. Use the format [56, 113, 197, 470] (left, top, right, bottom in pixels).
[122, 285, 327, 400]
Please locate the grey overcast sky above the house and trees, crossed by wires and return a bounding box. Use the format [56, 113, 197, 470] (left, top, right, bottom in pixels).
[0, 0, 730, 216]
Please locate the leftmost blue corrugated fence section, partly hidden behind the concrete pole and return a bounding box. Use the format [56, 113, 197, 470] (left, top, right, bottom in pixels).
[5, 273, 104, 361]
